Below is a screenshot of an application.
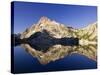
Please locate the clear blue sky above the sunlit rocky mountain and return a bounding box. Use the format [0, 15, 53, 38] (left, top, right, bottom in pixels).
[14, 2, 97, 33]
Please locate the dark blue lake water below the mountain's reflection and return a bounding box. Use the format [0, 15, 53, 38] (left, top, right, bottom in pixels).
[14, 46, 97, 73]
